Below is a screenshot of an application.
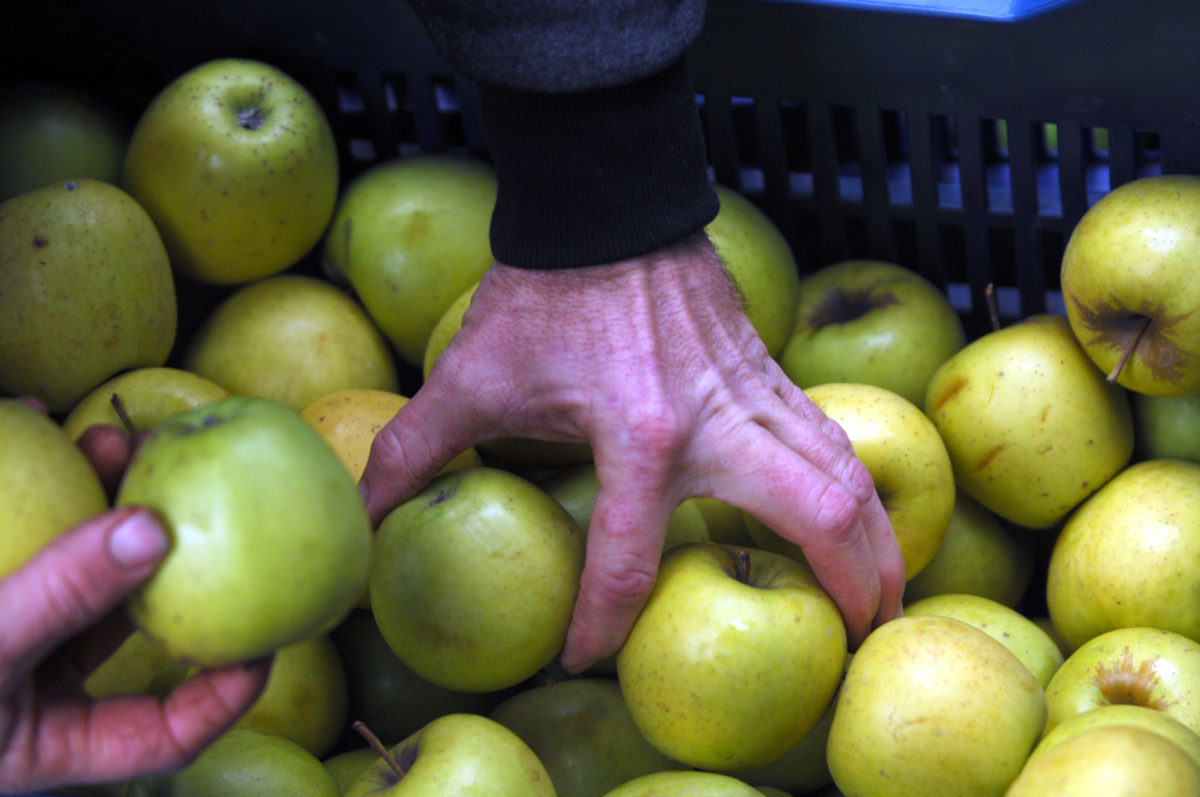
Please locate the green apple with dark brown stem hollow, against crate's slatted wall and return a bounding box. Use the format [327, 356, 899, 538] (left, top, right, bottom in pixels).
[779, 259, 966, 406]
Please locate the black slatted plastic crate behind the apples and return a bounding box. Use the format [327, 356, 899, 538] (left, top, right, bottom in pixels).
[7, 0, 1200, 334]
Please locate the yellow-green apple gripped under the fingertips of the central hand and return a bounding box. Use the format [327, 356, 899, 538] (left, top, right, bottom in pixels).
[617, 543, 846, 772]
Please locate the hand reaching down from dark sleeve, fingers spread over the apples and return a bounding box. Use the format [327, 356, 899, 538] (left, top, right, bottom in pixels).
[362, 233, 904, 670]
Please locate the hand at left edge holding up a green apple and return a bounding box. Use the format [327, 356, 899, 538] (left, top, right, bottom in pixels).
[0, 408, 269, 793]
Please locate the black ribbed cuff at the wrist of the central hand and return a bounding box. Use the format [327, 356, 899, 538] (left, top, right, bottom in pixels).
[480, 60, 719, 269]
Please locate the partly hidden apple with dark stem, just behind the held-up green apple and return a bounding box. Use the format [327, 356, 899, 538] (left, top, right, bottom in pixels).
[62, 366, 229, 441]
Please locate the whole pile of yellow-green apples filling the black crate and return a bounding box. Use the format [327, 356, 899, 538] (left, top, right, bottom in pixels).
[7, 59, 1200, 797]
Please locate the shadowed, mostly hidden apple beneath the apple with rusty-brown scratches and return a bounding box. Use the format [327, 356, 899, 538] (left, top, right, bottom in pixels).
[904, 490, 1036, 607]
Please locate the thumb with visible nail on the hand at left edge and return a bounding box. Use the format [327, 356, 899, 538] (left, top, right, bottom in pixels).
[0, 507, 169, 688]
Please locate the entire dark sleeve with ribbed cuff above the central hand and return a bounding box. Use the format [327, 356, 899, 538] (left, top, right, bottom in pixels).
[410, 0, 718, 269]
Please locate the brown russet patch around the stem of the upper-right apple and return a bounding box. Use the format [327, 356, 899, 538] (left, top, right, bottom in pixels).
[1070, 294, 1195, 384]
